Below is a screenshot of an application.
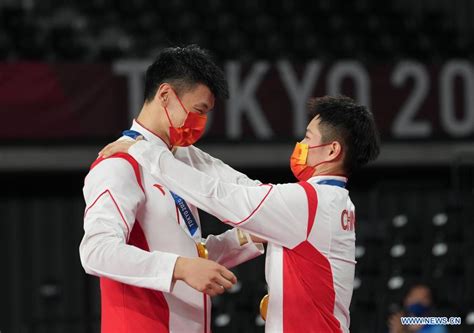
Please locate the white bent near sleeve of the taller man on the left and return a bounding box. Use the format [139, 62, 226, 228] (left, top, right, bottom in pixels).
[79, 158, 178, 292]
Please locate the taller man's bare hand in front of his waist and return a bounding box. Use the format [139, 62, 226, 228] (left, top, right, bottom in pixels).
[173, 257, 237, 296]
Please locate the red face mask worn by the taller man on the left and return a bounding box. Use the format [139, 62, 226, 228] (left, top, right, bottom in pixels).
[164, 90, 207, 147]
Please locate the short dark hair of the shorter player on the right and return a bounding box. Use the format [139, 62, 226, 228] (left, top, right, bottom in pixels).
[308, 96, 380, 174]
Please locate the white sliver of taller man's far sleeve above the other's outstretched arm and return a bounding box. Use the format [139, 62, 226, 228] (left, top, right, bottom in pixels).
[174, 146, 261, 186]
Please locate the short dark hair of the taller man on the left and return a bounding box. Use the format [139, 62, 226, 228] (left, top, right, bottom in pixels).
[145, 45, 229, 102]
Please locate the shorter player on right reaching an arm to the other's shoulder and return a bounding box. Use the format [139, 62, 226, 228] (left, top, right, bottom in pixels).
[101, 97, 379, 333]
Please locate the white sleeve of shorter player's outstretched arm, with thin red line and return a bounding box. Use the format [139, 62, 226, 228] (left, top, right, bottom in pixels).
[129, 141, 308, 248]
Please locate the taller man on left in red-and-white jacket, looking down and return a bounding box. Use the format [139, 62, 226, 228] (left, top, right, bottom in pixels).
[80, 46, 263, 333]
